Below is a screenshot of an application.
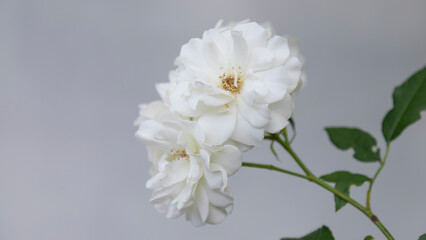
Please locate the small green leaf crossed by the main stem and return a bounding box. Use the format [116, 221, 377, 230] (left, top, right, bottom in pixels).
[320, 171, 370, 212]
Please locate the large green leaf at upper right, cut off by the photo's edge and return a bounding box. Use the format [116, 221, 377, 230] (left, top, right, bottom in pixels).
[382, 67, 426, 143]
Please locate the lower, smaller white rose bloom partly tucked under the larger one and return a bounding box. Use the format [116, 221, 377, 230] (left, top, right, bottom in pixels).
[136, 102, 241, 226]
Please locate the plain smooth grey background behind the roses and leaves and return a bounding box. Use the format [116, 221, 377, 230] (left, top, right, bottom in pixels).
[0, 0, 426, 240]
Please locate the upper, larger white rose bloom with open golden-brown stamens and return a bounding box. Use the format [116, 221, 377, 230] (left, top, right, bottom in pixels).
[158, 22, 305, 149]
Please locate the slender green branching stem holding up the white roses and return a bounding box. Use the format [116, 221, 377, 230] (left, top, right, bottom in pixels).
[243, 134, 395, 240]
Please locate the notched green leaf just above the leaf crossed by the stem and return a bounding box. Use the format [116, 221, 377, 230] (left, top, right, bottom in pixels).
[325, 127, 380, 162]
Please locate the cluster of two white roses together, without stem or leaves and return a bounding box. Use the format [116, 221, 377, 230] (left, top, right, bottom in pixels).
[136, 21, 305, 226]
